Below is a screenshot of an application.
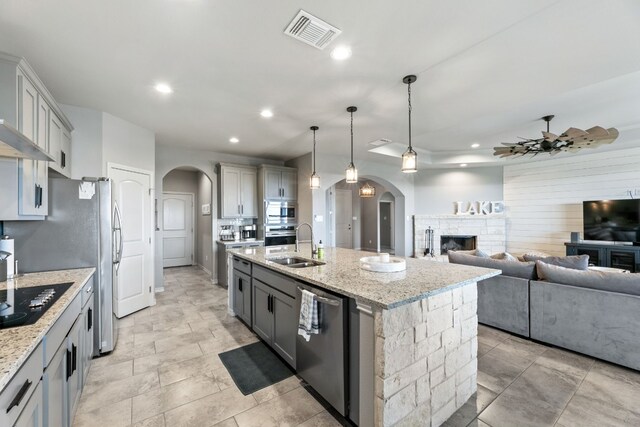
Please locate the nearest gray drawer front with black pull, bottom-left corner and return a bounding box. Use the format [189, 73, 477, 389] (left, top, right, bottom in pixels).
[0, 343, 43, 426]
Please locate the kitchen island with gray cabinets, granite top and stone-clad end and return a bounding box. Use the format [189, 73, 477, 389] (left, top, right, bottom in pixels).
[228, 246, 500, 427]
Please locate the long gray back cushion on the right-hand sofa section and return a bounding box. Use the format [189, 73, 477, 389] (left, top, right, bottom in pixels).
[536, 261, 640, 296]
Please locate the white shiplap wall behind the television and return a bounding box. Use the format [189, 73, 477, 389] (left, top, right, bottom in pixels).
[504, 148, 640, 255]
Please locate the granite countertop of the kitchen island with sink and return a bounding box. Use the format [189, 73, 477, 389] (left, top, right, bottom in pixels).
[229, 244, 501, 309]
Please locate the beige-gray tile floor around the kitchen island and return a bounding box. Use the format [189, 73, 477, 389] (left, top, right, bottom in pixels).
[73, 267, 640, 427]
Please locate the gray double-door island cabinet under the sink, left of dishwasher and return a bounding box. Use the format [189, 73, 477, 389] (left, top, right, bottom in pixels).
[252, 278, 298, 369]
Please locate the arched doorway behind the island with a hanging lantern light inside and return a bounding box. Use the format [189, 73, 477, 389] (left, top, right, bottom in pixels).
[326, 176, 405, 255]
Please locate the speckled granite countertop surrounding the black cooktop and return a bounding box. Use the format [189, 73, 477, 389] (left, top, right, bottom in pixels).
[0, 268, 95, 390]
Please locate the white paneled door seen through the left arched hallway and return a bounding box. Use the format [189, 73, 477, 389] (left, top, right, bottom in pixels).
[162, 193, 194, 267]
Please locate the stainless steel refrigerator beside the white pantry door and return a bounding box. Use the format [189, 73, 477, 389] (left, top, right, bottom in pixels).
[4, 178, 122, 356]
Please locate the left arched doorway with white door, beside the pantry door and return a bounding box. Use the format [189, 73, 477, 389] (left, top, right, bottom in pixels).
[161, 166, 215, 275]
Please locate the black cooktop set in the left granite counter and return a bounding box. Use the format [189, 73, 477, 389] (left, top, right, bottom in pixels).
[0, 282, 73, 329]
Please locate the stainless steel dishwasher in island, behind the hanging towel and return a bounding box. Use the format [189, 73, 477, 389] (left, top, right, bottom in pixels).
[296, 283, 349, 416]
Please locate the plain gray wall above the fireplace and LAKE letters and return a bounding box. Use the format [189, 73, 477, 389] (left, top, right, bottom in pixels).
[414, 166, 504, 215]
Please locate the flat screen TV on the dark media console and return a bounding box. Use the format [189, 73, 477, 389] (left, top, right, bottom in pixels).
[582, 199, 640, 242]
